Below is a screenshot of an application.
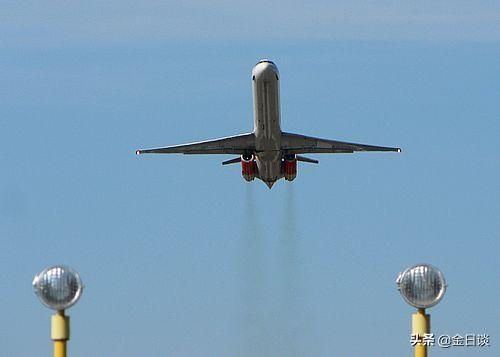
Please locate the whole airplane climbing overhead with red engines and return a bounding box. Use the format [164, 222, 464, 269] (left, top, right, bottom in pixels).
[136, 59, 401, 189]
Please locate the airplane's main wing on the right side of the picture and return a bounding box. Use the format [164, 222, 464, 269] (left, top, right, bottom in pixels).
[281, 133, 401, 154]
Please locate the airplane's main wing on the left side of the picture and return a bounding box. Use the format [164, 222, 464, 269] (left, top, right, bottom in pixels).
[136, 133, 255, 155]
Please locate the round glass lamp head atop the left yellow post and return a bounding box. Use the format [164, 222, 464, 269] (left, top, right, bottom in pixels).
[33, 265, 83, 310]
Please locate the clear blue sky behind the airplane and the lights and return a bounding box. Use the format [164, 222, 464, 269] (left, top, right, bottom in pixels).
[0, 1, 500, 357]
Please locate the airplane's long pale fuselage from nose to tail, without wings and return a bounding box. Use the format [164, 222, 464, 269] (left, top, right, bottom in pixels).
[252, 60, 283, 187]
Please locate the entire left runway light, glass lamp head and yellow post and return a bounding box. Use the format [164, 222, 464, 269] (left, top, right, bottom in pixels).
[33, 265, 83, 357]
